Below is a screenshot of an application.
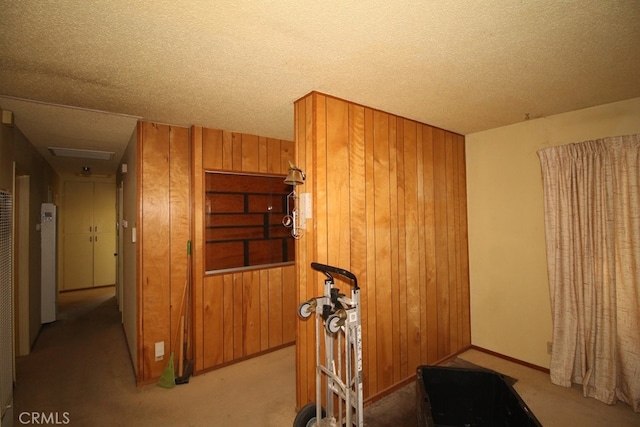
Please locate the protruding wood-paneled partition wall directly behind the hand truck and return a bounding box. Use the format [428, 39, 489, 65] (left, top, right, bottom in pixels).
[295, 92, 471, 407]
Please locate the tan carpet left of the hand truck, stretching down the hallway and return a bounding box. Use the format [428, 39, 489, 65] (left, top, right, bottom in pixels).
[14, 287, 295, 426]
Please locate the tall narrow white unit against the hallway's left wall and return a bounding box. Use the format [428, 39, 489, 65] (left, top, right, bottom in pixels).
[40, 203, 58, 323]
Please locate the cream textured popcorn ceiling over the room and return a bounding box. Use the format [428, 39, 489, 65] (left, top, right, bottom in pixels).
[0, 0, 640, 176]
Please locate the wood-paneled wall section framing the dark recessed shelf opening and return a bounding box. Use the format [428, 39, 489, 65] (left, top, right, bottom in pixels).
[192, 126, 297, 371]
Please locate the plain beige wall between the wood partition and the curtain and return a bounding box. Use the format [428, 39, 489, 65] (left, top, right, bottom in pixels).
[466, 98, 640, 368]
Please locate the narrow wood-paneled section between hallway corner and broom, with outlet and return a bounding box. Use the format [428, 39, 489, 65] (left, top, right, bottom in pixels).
[138, 122, 191, 383]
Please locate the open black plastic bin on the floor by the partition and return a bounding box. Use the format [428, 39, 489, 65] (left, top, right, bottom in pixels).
[416, 366, 542, 427]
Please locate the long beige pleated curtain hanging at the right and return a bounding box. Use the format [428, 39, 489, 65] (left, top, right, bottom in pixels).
[538, 135, 640, 412]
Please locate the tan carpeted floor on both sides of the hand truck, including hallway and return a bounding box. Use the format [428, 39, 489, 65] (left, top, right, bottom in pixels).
[14, 288, 640, 427]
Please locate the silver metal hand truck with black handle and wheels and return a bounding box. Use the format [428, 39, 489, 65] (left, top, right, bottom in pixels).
[293, 262, 364, 427]
